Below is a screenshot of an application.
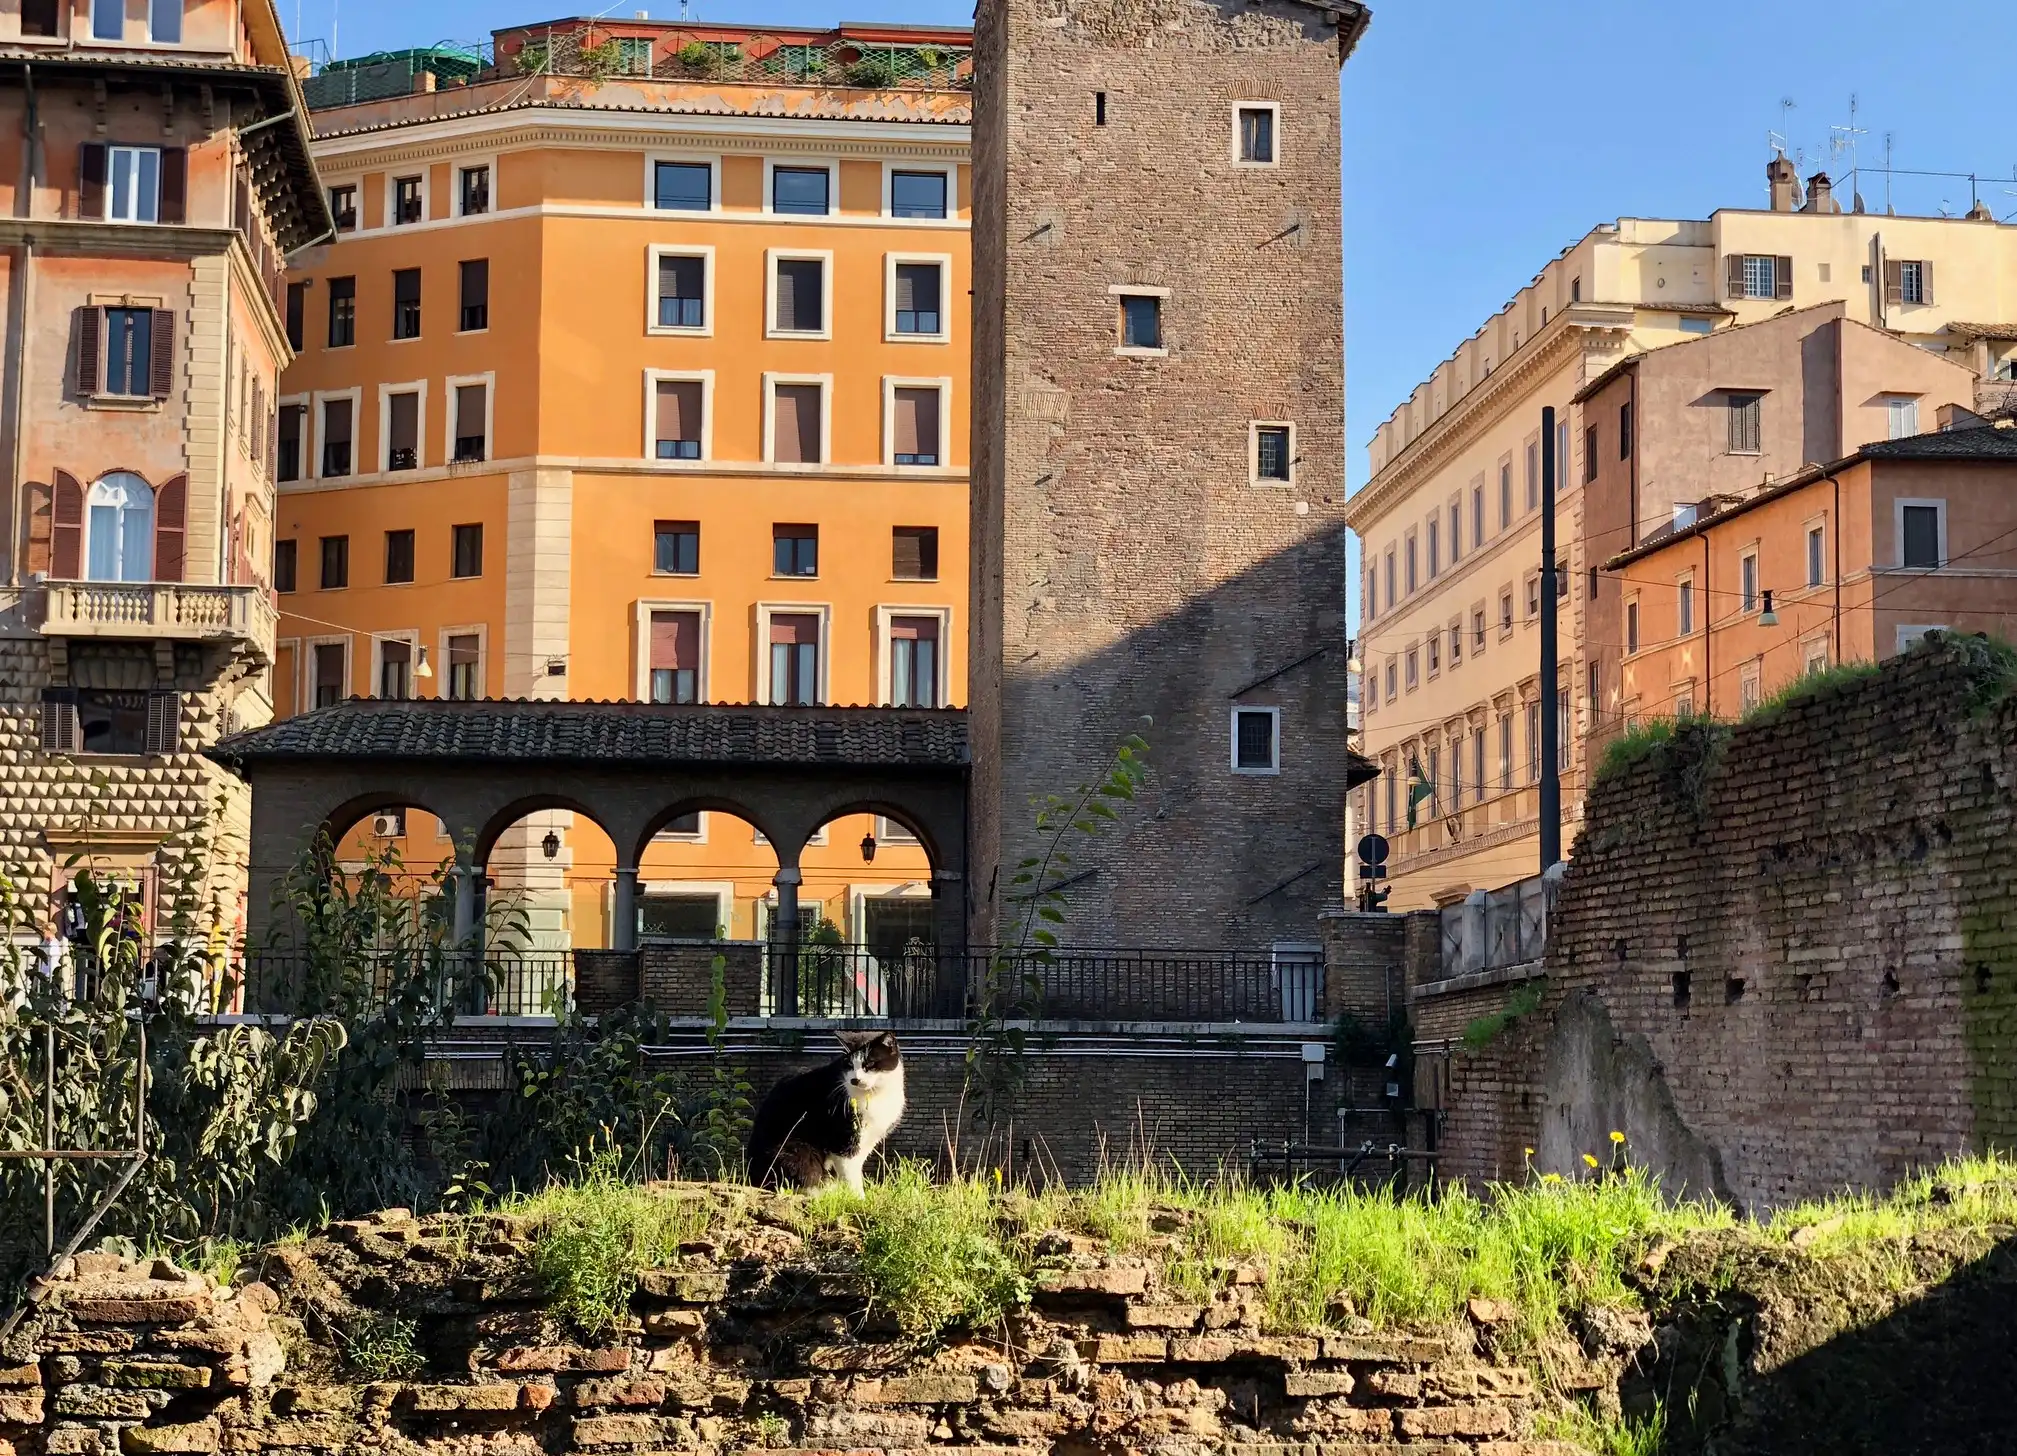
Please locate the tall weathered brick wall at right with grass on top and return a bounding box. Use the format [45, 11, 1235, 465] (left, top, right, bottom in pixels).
[1416, 637, 2017, 1208]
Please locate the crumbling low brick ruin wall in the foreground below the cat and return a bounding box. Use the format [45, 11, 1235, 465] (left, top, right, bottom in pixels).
[0, 1188, 1573, 1456]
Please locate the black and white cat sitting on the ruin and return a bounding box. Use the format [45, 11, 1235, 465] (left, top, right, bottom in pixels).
[748, 1030, 904, 1194]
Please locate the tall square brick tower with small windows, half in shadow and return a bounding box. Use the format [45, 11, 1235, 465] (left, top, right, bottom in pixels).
[968, 0, 1368, 948]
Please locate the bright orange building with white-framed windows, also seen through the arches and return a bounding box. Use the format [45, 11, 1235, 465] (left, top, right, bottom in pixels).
[274, 20, 970, 946]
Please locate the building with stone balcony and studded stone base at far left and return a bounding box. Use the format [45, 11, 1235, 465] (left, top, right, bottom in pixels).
[0, 0, 329, 936]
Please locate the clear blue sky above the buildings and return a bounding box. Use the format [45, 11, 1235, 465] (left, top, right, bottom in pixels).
[298, 0, 2017, 536]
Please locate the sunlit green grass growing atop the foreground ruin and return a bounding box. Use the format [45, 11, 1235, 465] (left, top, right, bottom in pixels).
[504, 1145, 2017, 1345]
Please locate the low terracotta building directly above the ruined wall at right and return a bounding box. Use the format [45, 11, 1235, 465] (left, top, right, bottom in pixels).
[1595, 421, 2017, 721]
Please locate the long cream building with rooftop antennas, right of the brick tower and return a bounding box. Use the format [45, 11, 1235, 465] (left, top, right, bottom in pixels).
[1345, 159, 2017, 909]
